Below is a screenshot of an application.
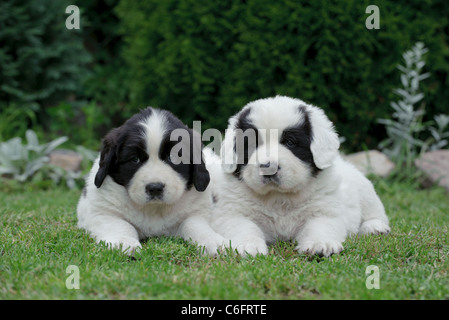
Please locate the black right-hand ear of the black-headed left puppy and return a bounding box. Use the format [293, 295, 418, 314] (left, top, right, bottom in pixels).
[189, 129, 210, 192]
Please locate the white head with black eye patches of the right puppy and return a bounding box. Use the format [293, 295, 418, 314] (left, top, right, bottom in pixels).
[222, 96, 340, 194]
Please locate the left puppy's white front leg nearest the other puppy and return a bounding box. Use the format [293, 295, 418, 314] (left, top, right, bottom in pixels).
[177, 216, 227, 256]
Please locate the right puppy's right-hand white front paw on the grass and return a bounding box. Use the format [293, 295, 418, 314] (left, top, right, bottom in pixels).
[296, 217, 346, 257]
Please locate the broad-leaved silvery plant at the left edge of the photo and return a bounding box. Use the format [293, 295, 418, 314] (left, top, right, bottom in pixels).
[0, 130, 67, 182]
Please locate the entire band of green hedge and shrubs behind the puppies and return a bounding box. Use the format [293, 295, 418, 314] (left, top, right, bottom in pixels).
[0, 0, 449, 151]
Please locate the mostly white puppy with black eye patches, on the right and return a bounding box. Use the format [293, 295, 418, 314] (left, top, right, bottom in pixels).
[213, 96, 390, 256]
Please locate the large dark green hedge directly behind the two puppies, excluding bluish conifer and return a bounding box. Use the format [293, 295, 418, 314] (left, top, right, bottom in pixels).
[116, 0, 449, 149]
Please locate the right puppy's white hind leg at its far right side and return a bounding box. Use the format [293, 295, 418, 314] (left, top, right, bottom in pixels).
[359, 183, 390, 234]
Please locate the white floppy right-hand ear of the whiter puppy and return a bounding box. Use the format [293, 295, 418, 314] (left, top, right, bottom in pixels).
[308, 106, 340, 169]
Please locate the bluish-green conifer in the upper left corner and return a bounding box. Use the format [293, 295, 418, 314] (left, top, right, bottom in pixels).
[0, 0, 89, 107]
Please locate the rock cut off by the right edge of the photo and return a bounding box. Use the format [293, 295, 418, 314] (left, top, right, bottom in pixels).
[415, 150, 449, 191]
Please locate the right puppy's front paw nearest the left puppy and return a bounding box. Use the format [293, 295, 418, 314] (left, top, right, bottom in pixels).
[214, 215, 268, 256]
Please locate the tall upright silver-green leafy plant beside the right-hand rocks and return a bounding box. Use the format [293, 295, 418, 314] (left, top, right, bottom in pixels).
[378, 42, 449, 168]
